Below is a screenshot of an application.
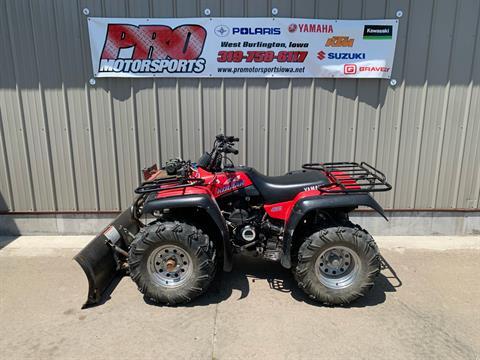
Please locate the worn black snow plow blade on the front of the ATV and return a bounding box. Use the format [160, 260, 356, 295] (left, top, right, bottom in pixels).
[74, 207, 141, 308]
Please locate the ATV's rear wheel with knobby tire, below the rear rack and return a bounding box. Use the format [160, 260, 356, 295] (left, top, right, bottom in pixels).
[294, 224, 380, 305]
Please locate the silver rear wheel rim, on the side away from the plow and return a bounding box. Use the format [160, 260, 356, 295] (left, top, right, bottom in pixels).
[315, 246, 361, 289]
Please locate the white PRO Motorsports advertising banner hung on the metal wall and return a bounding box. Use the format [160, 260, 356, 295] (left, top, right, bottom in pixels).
[88, 17, 398, 79]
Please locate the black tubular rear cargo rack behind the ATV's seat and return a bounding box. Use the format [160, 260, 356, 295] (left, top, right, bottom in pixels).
[302, 162, 392, 193]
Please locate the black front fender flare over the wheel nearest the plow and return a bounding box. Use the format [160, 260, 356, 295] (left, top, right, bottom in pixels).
[143, 193, 233, 271]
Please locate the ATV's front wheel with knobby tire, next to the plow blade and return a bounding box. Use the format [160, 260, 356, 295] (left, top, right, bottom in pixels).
[128, 221, 216, 305]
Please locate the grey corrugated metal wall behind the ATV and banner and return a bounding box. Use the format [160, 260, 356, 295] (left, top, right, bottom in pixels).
[0, 0, 480, 211]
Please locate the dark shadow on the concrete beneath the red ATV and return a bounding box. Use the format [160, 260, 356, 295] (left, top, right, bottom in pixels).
[144, 256, 402, 308]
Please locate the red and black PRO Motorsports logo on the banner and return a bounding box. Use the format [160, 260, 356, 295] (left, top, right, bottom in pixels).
[98, 24, 207, 73]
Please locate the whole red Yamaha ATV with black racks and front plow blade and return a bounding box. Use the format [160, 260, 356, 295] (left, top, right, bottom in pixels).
[75, 135, 391, 305]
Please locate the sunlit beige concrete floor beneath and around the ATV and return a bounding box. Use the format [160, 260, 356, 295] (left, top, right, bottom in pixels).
[0, 238, 480, 359]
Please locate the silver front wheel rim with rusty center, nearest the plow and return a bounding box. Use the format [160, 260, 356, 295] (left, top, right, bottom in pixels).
[147, 245, 193, 288]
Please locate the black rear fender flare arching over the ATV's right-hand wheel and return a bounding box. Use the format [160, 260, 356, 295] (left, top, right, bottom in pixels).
[281, 194, 388, 269]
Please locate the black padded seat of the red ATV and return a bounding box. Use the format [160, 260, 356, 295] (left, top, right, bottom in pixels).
[241, 167, 330, 204]
